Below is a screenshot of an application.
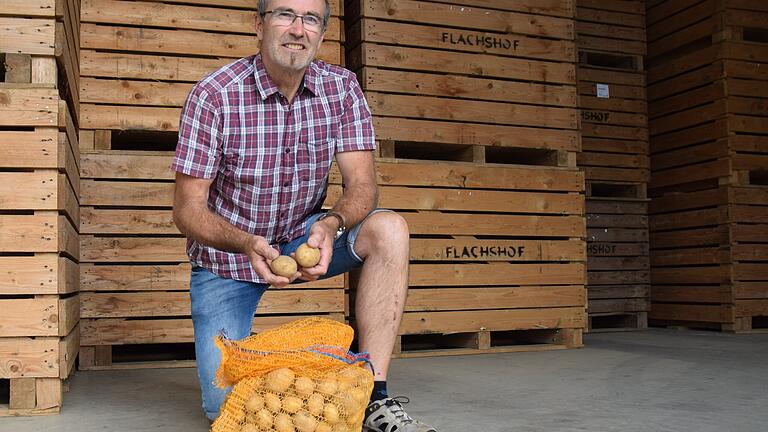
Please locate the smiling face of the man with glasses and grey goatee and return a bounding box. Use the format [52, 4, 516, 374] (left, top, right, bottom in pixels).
[256, 0, 325, 72]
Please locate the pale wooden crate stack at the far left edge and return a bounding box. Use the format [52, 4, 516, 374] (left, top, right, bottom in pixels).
[0, 0, 80, 416]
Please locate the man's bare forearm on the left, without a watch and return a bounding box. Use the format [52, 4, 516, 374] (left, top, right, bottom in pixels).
[173, 205, 253, 252]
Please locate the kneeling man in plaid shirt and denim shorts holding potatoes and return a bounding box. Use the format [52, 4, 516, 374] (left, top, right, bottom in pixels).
[172, 0, 435, 432]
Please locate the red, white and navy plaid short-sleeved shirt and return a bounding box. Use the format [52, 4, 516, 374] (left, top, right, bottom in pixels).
[171, 55, 375, 283]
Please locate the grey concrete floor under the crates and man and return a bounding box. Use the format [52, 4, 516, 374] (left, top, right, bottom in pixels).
[0, 329, 768, 432]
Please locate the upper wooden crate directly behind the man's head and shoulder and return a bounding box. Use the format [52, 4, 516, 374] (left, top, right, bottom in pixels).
[80, 0, 344, 150]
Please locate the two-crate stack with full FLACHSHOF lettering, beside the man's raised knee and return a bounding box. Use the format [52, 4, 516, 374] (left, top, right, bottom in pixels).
[345, 0, 586, 356]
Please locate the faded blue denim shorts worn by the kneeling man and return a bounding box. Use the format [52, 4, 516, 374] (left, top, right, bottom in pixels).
[189, 209, 388, 420]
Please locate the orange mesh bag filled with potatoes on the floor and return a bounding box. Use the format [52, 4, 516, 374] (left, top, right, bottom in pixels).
[211, 317, 373, 432]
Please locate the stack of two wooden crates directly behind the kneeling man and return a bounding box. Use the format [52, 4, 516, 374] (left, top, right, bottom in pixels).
[80, 0, 345, 369]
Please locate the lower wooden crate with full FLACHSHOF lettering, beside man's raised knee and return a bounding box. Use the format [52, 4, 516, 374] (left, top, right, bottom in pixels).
[340, 160, 586, 357]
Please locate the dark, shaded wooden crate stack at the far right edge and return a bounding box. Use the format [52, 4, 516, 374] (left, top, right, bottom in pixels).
[647, 0, 768, 331]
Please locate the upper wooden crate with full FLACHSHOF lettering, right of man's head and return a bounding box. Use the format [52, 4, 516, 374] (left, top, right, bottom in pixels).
[345, 0, 579, 167]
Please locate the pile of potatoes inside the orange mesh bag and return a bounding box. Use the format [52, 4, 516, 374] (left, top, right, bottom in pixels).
[240, 366, 373, 432]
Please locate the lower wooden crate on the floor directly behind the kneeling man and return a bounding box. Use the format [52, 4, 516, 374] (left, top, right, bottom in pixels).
[80, 150, 345, 369]
